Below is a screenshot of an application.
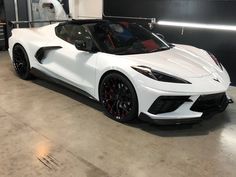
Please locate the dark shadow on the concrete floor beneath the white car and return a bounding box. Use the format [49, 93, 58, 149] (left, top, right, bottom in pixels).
[32, 79, 231, 137]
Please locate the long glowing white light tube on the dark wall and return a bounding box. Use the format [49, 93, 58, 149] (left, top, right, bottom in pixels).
[157, 20, 236, 31]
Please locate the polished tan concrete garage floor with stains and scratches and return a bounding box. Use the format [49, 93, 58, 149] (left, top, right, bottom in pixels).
[0, 52, 236, 177]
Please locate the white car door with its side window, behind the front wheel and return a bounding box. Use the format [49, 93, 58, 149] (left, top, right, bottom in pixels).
[42, 24, 97, 96]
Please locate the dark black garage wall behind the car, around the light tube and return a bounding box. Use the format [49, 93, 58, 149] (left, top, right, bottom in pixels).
[104, 0, 236, 85]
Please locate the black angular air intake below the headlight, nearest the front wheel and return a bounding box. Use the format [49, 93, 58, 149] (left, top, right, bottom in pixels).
[148, 96, 189, 114]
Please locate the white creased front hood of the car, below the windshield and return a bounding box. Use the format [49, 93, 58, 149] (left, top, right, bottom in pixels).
[125, 45, 217, 78]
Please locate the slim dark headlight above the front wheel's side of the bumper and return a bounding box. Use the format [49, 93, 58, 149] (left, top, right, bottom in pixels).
[132, 66, 191, 84]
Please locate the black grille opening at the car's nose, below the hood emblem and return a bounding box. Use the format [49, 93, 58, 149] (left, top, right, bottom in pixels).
[191, 93, 229, 113]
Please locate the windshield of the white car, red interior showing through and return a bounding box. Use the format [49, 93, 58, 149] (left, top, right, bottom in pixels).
[88, 22, 170, 55]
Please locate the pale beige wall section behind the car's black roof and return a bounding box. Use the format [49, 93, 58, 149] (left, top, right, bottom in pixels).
[69, 0, 103, 19]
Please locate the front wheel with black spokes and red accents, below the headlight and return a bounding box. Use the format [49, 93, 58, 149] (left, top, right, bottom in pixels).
[99, 73, 138, 122]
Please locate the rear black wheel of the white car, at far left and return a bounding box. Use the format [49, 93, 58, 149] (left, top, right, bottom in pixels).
[12, 44, 32, 80]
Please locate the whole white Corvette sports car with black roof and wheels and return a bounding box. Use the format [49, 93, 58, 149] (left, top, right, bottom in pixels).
[9, 20, 230, 124]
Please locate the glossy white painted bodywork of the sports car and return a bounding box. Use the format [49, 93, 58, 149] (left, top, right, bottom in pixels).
[9, 24, 230, 119]
